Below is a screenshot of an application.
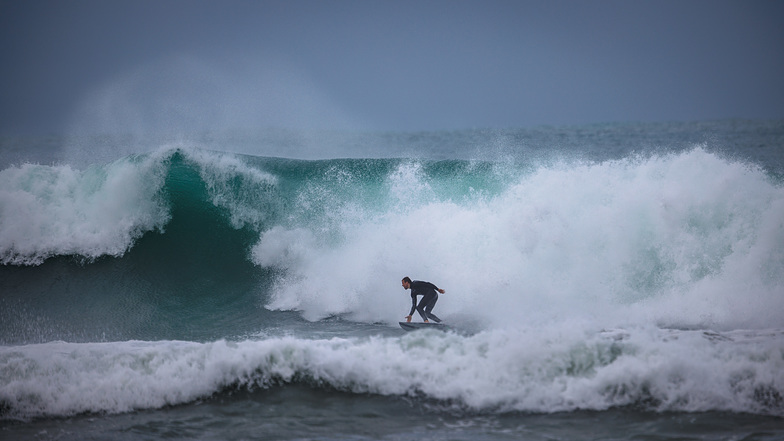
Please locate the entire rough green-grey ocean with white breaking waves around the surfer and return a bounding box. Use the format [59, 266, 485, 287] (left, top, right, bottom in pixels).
[0, 120, 784, 440]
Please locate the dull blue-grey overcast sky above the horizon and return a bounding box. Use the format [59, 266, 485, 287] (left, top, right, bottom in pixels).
[0, 0, 784, 134]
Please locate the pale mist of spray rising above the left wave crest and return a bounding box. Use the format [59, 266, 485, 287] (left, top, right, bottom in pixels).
[55, 53, 372, 165]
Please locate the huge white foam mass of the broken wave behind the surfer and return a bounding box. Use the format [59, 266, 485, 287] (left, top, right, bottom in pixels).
[254, 148, 784, 329]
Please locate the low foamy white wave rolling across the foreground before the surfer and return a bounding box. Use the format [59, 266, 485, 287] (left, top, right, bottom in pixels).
[0, 329, 784, 418]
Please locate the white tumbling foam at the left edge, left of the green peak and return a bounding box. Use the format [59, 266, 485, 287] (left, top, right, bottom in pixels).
[0, 151, 169, 265]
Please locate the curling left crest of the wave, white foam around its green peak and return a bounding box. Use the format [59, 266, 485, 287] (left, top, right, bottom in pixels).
[0, 146, 278, 265]
